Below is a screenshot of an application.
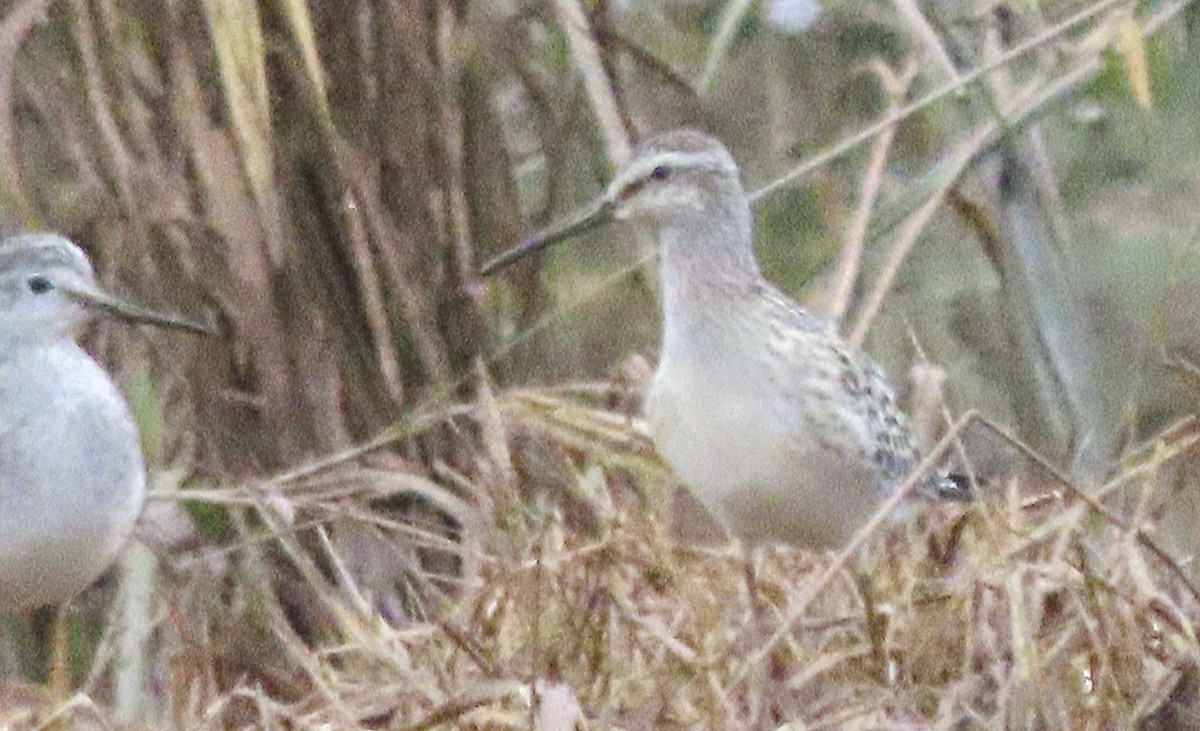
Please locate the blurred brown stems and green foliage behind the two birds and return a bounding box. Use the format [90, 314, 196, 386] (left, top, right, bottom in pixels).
[7, 0, 1200, 720]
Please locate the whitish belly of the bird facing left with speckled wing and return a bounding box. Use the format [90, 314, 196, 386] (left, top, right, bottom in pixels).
[646, 367, 880, 549]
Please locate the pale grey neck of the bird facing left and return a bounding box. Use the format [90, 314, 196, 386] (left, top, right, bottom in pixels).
[658, 203, 762, 353]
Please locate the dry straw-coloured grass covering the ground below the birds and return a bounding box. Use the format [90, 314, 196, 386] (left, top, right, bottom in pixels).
[4, 389, 1200, 729]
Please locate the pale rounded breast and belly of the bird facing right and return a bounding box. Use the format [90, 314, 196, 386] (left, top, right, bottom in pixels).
[0, 343, 145, 609]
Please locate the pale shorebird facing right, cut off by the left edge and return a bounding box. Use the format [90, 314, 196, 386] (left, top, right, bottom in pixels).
[0, 233, 212, 611]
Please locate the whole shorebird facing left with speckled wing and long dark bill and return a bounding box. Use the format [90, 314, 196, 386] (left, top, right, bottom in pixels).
[484, 130, 966, 549]
